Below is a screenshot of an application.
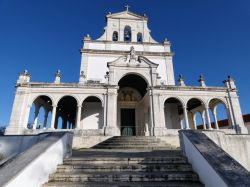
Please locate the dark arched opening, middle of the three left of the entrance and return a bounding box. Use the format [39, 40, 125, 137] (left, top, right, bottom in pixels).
[54, 96, 77, 129]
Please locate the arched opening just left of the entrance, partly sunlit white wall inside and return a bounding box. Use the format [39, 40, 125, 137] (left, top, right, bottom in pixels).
[80, 96, 104, 129]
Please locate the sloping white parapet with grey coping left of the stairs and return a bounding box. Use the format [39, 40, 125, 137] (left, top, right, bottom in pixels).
[0, 132, 73, 187]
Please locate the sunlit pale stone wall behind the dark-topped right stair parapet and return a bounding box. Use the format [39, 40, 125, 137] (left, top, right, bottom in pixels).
[203, 131, 250, 171]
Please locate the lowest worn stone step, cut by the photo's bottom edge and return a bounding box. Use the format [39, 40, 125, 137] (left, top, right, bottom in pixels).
[43, 181, 204, 187]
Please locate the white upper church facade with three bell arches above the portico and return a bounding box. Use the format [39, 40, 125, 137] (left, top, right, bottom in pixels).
[80, 6, 175, 85]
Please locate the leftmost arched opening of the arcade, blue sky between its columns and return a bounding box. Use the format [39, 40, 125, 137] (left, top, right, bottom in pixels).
[27, 95, 52, 129]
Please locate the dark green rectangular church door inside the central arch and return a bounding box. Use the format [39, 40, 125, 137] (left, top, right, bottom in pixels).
[121, 108, 136, 136]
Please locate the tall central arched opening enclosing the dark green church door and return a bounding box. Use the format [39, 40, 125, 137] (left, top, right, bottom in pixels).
[117, 74, 150, 136]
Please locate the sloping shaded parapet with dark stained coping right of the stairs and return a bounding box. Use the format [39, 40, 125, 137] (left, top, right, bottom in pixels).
[180, 130, 250, 187]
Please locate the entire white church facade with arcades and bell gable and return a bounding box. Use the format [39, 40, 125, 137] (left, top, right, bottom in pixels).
[6, 9, 247, 136]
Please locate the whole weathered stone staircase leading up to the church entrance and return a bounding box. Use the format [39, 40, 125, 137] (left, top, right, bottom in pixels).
[43, 137, 203, 187]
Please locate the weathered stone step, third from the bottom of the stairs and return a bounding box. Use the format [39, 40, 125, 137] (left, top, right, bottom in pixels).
[57, 163, 192, 173]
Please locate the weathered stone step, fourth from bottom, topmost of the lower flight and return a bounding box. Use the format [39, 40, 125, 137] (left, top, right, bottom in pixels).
[63, 156, 187, 164]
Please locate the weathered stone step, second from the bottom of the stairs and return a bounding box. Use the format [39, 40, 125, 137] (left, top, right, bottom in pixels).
[49, 172, 198, 182]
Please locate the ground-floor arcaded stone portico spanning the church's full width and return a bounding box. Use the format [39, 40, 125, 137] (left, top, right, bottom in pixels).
[4, 73, 247, 136]
